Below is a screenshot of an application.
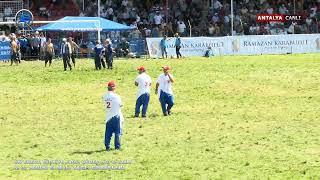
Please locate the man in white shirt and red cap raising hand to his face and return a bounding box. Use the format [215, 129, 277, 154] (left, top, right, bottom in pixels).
[155, 66, 174, 116]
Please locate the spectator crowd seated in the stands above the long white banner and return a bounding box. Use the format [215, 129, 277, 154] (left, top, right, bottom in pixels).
[80, 0, 320, 39]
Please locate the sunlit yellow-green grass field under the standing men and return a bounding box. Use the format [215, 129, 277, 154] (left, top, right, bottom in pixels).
[0, 54, 320, 179]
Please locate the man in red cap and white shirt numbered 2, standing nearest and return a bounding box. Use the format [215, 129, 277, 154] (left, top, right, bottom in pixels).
[103, 81, 124, 151]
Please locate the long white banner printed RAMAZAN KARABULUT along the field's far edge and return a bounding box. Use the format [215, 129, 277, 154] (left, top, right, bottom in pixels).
[147, 34, 320, 58]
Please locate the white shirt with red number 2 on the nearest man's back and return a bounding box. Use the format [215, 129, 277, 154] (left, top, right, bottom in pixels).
[103, 91, 124, 122]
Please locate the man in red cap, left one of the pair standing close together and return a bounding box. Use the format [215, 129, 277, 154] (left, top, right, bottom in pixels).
[134, 66, 152, 118]
